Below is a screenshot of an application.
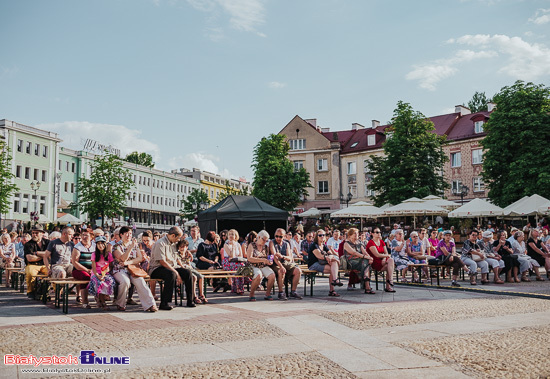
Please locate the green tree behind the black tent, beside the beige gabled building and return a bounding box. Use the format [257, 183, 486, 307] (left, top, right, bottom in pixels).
[252, 134, 311, 211]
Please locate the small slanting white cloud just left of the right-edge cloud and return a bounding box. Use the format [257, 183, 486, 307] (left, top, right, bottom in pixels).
[405, 49, 497, 91]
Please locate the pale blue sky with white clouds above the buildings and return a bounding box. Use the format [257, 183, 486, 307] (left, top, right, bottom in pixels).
[0, 0, 550, 180]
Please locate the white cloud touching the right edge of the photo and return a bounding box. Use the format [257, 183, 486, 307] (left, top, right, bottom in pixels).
[455, 34, 550, 80]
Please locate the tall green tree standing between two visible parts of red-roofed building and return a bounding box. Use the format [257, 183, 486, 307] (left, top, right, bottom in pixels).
[366, 101, 449, 206]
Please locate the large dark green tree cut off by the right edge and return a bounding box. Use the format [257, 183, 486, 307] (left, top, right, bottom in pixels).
[481, 81, 550, 207]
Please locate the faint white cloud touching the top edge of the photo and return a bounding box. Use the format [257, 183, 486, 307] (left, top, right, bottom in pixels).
[187, 0, 266, 41]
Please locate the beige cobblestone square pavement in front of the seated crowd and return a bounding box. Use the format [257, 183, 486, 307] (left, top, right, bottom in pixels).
[0, 278, 550, 378]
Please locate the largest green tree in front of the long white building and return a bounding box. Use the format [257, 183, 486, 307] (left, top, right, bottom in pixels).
[73, 153, 134, 226]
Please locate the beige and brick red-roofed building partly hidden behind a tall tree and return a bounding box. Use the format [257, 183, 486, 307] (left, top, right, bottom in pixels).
[279, 104, 494, 211]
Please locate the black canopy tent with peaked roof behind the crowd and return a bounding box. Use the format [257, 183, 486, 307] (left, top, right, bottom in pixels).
[198, 195, 294, 237]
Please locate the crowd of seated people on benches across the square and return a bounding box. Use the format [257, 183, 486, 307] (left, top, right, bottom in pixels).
[0, 220, 550, 312]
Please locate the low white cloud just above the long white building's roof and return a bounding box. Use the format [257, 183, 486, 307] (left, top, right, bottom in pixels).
[36, 121, 161, 165]
